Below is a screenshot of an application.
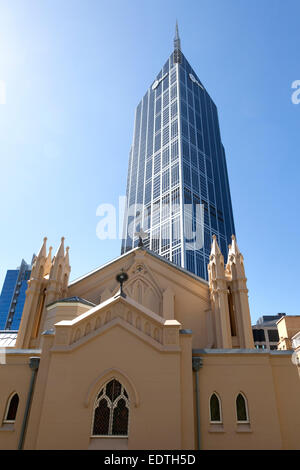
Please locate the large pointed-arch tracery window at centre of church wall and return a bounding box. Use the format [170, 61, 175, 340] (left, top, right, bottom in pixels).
[92, 379, 129, 436]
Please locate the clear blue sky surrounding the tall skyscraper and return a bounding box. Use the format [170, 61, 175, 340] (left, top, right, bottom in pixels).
[0, 0, 300, 322]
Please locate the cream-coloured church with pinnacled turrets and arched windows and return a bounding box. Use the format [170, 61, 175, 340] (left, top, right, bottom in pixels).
[0, 237, 300, 450]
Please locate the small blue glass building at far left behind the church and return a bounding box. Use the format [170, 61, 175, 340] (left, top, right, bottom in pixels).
[0, 260, 31, 330]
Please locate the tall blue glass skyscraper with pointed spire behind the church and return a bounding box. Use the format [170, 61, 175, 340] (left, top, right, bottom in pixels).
[122, 24, 235, 279]
